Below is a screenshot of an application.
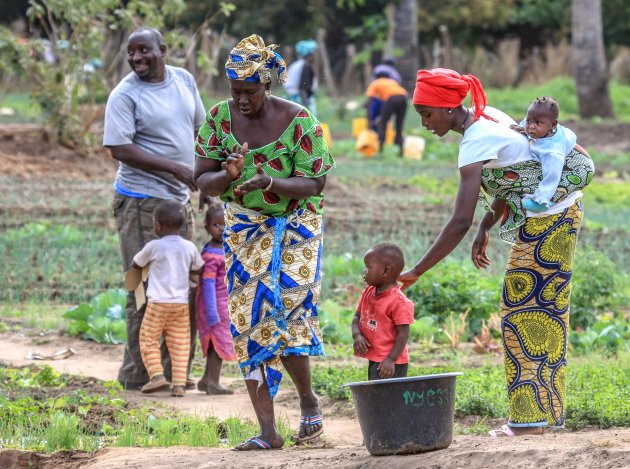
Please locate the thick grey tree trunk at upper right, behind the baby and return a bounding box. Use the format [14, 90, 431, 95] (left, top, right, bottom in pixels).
[572, 0, 614, 119]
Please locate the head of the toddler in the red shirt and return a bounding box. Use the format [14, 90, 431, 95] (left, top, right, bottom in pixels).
[363, 243, 405, 287]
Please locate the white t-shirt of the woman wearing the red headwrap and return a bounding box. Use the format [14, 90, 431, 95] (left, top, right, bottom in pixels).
[458, 107, 582, 217]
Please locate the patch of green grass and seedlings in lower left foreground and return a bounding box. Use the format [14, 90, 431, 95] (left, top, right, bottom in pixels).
[0, 366, 295, 452]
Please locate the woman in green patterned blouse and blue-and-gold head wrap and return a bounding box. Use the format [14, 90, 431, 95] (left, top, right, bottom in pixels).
[195, 35, 334, 451]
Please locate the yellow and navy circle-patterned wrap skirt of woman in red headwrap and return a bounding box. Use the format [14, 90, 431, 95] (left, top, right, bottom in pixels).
[501, 198, 583, 427]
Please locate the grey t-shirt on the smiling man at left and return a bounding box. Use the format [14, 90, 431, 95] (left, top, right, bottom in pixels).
[103, 65, 205, 203]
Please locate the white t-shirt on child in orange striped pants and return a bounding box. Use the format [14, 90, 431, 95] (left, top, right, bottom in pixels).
[133, 235, 203, 304]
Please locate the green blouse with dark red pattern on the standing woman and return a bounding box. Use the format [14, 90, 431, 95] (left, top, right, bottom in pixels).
[195, 101, 335, 217]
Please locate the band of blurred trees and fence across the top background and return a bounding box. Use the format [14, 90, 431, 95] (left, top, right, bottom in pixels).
[0, 0, 630, 143]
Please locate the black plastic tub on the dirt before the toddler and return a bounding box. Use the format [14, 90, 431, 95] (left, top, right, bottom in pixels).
[344, 373, 461, 456]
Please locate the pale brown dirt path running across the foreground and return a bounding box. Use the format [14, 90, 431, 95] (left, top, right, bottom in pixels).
[0, 333, 630, 469]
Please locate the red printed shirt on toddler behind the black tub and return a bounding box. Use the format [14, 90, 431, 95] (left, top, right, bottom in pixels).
[355, 286, 413, 365]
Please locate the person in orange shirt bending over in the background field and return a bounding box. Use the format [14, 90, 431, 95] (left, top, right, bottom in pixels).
[365, 72, 409, 156]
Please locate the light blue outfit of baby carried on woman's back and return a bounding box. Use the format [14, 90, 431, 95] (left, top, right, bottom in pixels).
[520, 119, 577, 211]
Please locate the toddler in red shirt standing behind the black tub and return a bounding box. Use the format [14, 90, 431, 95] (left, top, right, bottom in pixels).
[352, 243, 414, 380]
